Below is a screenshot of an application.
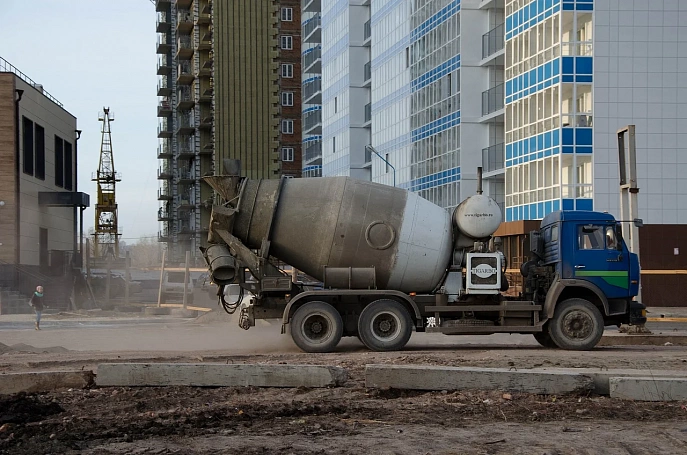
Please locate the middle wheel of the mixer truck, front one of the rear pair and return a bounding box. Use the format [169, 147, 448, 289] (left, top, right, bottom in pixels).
[358, 300, 413, 351]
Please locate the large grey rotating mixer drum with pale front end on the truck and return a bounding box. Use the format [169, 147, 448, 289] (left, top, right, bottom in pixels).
[223, 177, 452, 292]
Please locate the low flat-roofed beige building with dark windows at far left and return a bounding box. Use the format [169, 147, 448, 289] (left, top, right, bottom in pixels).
[0, 58, 90, 312]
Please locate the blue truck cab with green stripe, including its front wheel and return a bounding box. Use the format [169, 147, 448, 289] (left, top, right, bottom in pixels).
[521, 210, 646, 349]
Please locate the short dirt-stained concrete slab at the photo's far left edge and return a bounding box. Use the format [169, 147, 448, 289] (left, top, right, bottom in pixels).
[0, 370, 94, 395]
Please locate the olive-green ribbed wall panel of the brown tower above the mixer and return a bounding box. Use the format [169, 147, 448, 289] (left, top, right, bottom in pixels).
[213, 0, 279, 178]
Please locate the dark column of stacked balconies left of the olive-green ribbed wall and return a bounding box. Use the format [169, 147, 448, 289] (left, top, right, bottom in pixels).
[155, 0, 214, 262]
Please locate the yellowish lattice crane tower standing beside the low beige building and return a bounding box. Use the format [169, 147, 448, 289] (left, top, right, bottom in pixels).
[91, 107, 122, 259]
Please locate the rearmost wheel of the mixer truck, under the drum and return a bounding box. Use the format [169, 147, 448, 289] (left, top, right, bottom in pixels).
[290, 302, 343, 352]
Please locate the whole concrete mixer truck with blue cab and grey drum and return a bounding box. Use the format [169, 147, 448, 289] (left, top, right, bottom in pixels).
[203, 162, 646, 352]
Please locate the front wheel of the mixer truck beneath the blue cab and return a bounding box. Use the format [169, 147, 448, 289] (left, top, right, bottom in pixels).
[549, 299, 604, 351]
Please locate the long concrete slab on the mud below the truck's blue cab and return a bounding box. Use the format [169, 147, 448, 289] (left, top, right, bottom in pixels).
[365, 365, 594, 395]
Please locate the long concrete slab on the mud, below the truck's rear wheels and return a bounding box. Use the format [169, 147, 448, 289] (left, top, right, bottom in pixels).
[96, 363, 348, 387]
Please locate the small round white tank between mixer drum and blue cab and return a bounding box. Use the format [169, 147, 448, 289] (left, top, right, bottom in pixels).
[453, 194, 503, 240]
